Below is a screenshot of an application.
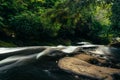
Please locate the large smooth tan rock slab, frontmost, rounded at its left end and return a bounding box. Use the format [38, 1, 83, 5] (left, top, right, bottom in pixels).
[58, 57, 120, 80]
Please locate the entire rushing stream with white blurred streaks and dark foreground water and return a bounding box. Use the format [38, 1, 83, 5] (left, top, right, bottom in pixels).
[0, 43, 120, 80]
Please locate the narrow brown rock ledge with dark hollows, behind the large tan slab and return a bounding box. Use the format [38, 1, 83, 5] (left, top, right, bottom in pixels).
[74, 53, 120, 69]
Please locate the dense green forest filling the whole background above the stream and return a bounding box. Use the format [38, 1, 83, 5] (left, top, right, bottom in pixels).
[0, 0, 120, 46]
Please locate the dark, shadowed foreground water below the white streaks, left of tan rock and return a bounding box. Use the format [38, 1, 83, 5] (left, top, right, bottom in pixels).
[0, 57, 96, 80]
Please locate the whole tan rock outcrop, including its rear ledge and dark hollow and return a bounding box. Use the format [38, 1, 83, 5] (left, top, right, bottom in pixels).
[58, 54, 120, 80]
